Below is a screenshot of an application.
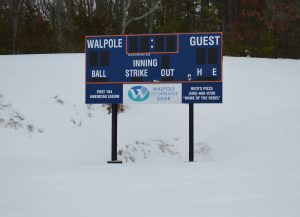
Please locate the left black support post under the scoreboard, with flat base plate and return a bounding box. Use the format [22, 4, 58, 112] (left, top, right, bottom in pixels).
[107, 104, 122, 163]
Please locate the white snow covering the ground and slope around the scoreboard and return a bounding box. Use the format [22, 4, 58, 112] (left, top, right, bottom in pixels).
[0, 54, 300, 217]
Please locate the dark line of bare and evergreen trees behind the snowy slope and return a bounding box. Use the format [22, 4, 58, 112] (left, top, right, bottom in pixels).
[0, 0, 300, 58]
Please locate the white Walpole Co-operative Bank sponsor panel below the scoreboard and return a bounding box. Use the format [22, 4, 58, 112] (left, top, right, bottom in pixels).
[123, 84, 182, 104]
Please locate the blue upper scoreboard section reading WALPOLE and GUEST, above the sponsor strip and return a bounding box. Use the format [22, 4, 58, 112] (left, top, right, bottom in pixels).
[85, 33, 222, 84]
